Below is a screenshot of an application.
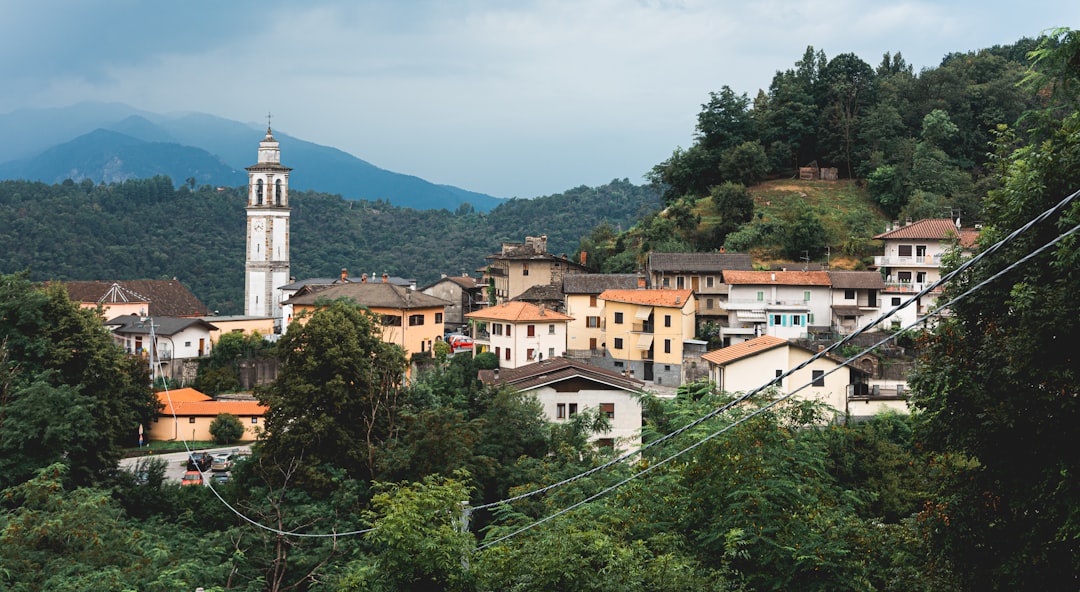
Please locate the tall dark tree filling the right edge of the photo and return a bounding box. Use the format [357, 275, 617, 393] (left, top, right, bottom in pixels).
[910, 31, 1080, 590]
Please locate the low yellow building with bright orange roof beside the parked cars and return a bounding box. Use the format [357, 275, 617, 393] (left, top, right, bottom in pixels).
[145, 389, 267, 442]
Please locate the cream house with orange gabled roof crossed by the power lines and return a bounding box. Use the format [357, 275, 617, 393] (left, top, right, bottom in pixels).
[702, 335, 865, 417]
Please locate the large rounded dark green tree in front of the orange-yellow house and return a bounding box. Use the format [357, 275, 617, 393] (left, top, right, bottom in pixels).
[256, 299, 406, 490]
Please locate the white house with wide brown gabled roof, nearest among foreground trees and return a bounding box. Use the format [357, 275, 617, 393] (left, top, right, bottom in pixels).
[480, 358, 644, 450]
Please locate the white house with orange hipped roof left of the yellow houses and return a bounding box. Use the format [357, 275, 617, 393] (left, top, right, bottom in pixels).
[465, 301, 572, 368]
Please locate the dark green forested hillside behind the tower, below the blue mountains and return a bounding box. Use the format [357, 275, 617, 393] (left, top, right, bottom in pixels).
[0, 177, 659, 314]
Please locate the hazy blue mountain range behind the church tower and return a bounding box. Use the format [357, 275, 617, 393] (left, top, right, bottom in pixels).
[0, 103, 503, 212]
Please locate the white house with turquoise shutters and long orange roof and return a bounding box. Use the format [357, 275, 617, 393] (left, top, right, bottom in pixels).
[720, 271, 832, 345]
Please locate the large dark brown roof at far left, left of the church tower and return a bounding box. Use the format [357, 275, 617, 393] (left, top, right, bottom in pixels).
[64, 280, 211, 317]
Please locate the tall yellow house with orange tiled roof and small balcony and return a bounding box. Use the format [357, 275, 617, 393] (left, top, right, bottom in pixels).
[594, 290, 696, 386]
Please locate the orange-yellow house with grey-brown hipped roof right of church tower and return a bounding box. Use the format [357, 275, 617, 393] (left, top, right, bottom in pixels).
[285, 282, 449, 354]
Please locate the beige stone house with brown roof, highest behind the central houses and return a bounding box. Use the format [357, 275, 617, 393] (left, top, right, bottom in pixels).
[483, 236, 589, 304]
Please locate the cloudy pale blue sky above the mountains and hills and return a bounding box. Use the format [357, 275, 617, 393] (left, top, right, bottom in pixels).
[0, 0, 1080, 198]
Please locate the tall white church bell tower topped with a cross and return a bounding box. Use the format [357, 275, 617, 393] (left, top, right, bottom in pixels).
[244, 125, 292, 331]
